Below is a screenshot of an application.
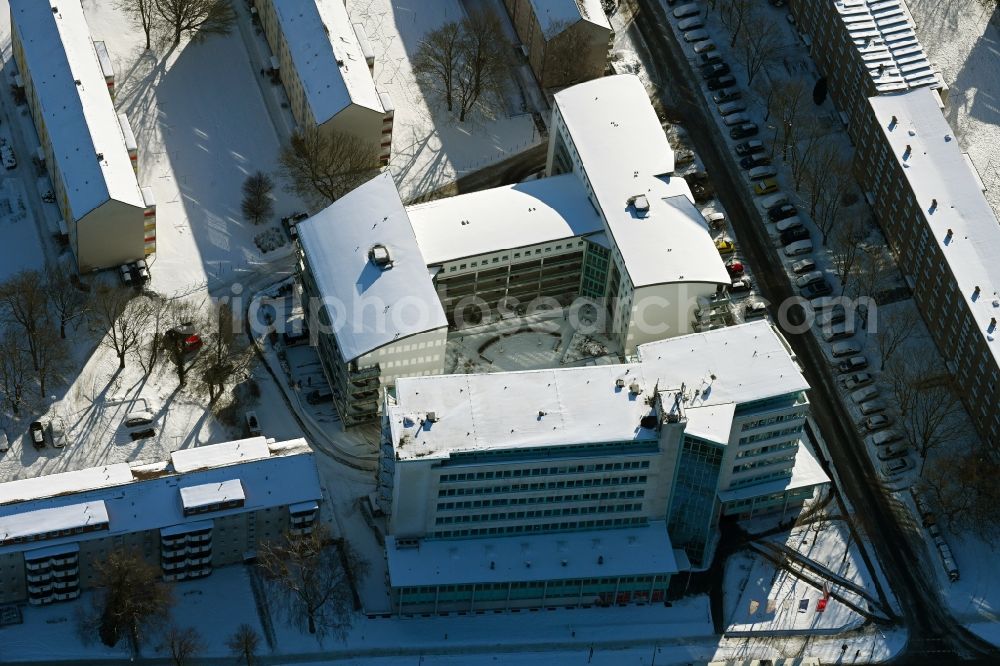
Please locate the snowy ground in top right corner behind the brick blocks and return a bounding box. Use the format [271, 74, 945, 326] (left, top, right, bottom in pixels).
[906, 0, 1000, 217]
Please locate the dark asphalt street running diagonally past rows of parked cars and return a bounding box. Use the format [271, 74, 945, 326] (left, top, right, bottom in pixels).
[630, 0, 1000, 664]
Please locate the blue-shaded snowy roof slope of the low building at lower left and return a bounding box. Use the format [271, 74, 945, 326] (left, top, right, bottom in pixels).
[0, 446, 322, 553]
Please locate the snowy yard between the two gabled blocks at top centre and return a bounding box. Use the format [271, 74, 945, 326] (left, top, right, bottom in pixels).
[347, 0, 548, 201]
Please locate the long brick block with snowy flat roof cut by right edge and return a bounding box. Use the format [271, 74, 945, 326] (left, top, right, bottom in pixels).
[856, 89, 1000, 446]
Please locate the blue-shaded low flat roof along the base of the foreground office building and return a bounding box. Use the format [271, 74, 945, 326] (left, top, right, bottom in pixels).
[385, 521, 677, 587]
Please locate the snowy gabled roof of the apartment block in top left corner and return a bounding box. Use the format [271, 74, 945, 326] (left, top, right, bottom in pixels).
[10, 0, 144, 220]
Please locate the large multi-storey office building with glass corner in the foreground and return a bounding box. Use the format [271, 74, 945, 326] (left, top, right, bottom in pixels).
[376, 322, 828, 613]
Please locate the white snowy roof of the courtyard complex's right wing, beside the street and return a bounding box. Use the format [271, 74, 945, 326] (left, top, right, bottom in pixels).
[556, 75, 730, 287]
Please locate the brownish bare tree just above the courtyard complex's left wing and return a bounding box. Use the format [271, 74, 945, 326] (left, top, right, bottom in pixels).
[278, 127, 379, 208]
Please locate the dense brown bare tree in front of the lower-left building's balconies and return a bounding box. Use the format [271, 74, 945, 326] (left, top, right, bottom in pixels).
[95, 550, 173, 652]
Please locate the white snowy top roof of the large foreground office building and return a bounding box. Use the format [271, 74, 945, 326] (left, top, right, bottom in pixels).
[388, 321, 809, 460]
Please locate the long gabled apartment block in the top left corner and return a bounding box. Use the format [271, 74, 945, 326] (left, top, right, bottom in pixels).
[10, 0, 156, 272]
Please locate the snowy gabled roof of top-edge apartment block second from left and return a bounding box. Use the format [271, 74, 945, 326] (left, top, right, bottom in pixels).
[271, 0, 384, 125]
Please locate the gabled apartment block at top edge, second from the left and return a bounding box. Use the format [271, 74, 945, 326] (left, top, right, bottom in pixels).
[254, 0, 393, 165]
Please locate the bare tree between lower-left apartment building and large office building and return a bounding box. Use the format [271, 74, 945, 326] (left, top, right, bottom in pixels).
[257, 524, 363, 637]
